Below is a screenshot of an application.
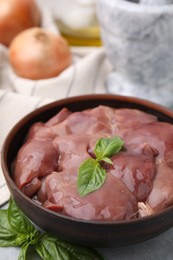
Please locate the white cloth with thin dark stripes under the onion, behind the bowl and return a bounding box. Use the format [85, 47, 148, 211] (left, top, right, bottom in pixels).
[0, 7, 111, 205]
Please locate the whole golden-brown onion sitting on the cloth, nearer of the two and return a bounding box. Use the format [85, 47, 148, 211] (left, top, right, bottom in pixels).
[9, 27, 72, 80]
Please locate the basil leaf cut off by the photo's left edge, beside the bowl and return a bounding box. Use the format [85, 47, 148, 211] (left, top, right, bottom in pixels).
[0, 209, 17, 247]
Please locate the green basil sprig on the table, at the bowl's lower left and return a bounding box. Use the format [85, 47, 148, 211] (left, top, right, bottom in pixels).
[0, 199, 104, 260]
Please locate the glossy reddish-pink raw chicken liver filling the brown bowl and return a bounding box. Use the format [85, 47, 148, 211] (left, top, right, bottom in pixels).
[14, 106, 173, 221]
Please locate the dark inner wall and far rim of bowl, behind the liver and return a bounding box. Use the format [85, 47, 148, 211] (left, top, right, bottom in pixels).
[6, 95, 173, 167]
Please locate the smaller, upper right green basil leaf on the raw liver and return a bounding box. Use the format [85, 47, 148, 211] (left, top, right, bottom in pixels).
[94, 136, 124, 161]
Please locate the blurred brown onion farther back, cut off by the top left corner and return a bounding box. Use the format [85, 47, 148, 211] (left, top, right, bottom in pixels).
[0, 0, 41, 47]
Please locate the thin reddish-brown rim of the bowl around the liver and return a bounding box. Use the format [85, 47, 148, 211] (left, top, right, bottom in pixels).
[1, 94, 173, 226]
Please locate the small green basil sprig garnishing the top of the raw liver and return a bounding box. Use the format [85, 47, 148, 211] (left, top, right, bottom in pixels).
[77, 136, 124, 197]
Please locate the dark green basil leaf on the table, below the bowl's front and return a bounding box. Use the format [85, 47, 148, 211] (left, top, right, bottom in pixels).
[36, 233, 104, 260]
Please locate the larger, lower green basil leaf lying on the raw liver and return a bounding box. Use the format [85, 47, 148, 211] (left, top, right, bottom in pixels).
[77, 158, 106, 196]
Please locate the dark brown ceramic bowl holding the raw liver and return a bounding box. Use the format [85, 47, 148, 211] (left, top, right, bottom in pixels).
[2, 94, 173, 247]
